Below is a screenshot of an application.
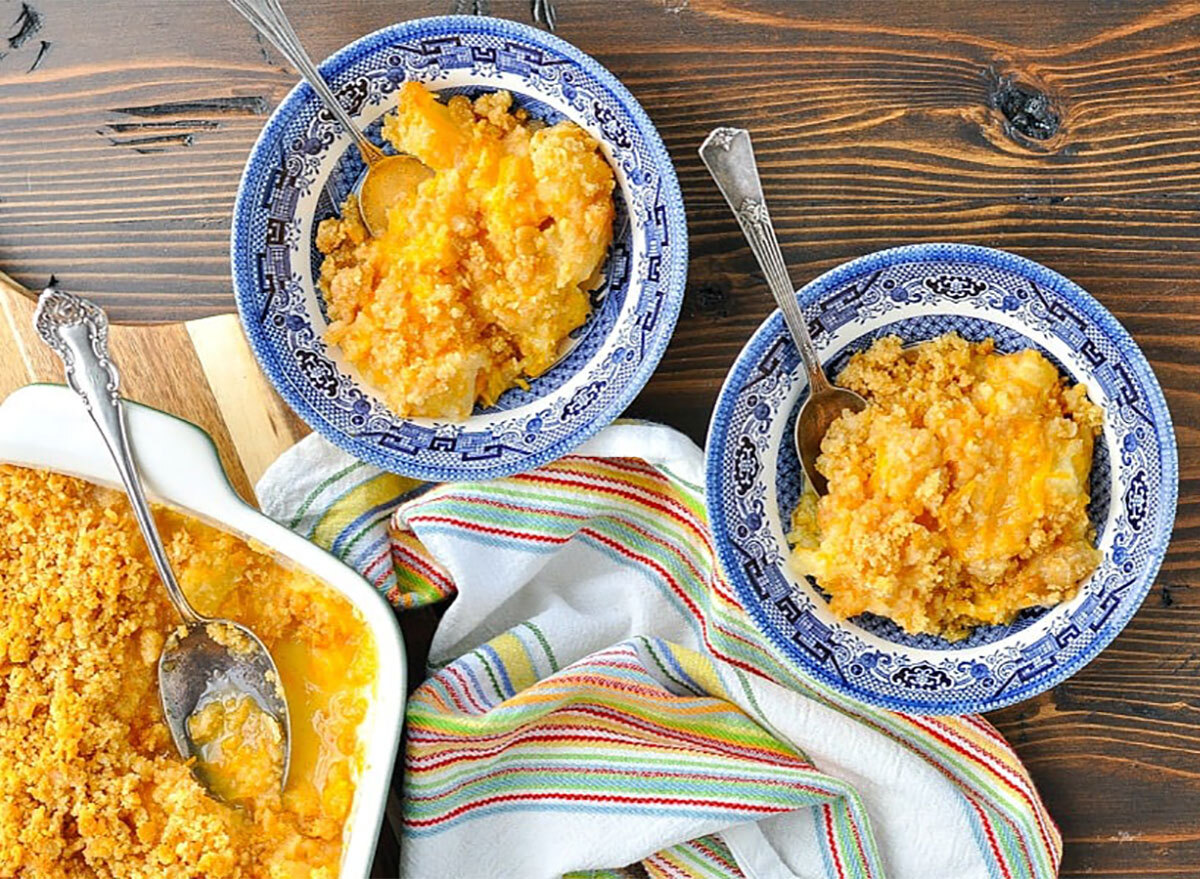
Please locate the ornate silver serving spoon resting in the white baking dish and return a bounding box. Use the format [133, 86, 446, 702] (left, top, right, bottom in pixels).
[34, 287, 292, 791]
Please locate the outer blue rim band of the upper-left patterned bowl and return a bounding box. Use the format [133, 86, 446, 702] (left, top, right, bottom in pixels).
[229, 16, 689, 482]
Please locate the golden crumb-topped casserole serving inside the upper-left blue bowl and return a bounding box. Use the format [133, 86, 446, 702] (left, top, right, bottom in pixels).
[317, 82, 614, 420]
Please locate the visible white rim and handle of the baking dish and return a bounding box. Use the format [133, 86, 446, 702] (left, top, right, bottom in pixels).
[0, 384, 407, 879]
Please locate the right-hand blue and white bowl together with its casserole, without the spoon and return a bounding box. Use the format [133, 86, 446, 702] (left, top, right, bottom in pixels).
[706, 244, 1178, 714]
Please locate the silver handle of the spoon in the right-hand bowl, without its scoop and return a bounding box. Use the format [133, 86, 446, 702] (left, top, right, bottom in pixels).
[700, 128, 830, 393]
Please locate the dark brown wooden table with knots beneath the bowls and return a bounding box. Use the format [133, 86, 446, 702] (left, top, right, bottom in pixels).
[0, 0, 1200, 879]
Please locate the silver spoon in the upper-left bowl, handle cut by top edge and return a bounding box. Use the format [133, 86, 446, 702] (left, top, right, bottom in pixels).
[229, 0, 433, 238]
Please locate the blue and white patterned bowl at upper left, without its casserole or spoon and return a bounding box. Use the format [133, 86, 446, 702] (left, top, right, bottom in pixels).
[232, 16, 688, 480]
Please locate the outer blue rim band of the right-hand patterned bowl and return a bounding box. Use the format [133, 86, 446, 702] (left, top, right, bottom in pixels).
[704, 241, 1178, 716]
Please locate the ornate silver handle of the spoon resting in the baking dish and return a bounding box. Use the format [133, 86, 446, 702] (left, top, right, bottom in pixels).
[34, 287, 204, 623]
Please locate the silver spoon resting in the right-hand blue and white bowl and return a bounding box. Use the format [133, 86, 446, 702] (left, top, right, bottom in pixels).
[700, 128, 866, 495]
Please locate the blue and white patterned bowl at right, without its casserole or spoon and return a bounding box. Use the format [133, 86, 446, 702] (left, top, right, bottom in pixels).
[706, 244, 1178, 714]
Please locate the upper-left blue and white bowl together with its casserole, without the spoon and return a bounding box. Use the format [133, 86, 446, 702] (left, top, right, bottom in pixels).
[230, 16, 688, 482]
